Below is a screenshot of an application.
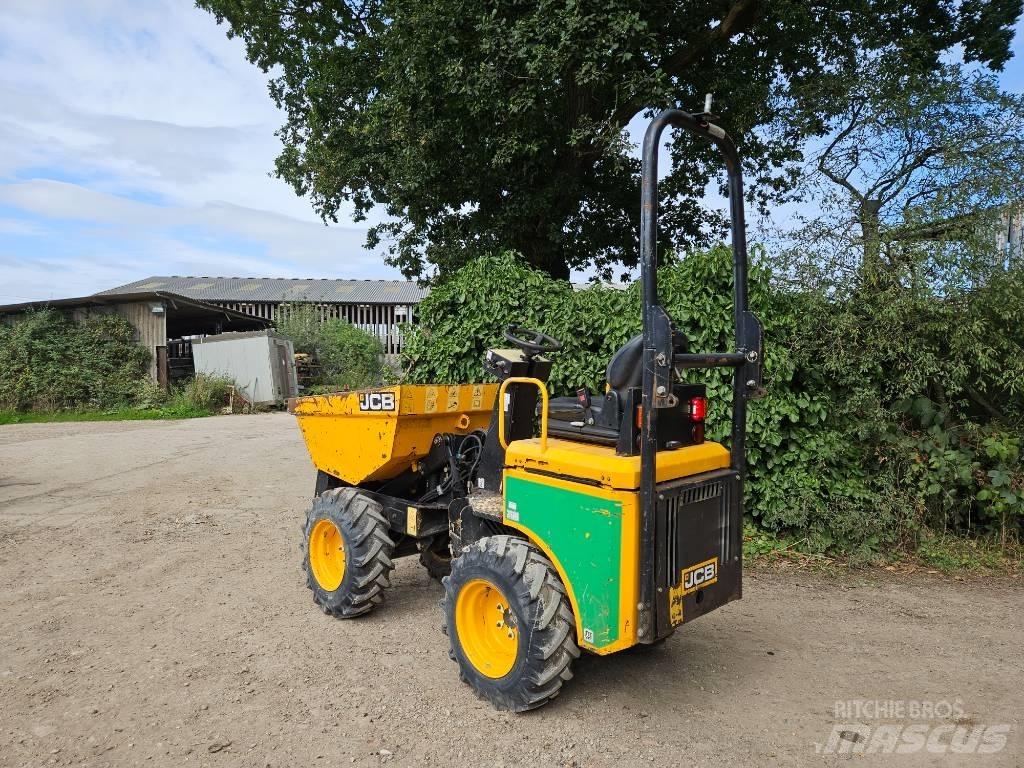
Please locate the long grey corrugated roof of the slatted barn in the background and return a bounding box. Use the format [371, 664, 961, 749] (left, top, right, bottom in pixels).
[96, 275, 427, 304]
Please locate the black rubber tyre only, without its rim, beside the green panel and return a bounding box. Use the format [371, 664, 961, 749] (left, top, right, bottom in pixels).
[441, 535, 580, 712]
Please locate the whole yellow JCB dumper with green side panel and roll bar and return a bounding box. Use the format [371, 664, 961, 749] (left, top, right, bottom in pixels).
[292, 111, 764, 712]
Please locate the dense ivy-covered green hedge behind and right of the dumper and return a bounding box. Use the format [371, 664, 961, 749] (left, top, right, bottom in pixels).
[404, 248, 1024, 552]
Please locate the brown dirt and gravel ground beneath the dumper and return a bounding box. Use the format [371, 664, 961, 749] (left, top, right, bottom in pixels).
[0, 414, 1024, 766]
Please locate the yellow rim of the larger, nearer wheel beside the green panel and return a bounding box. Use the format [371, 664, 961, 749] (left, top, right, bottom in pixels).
[455, 579, 519, 679]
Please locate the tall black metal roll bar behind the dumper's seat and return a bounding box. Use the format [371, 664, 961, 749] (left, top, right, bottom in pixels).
[638, 110, 762, 642]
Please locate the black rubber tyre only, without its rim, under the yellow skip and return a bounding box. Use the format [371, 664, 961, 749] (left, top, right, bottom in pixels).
[301, 487, 394, 618]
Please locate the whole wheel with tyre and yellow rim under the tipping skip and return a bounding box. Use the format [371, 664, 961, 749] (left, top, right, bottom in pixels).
[302, 487, 394, 618]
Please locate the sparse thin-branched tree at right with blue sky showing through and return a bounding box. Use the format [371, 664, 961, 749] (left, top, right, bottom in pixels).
[782, 59, 1024, 284]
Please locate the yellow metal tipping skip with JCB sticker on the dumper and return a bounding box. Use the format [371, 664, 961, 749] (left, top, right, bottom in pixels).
[289, 384, 498, 485]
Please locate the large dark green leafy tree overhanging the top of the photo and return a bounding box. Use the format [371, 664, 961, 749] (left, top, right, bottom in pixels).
[198, 0, 1021, 276]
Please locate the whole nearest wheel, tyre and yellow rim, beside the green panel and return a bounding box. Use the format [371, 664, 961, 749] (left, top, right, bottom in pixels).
[441, 536, 580, 712]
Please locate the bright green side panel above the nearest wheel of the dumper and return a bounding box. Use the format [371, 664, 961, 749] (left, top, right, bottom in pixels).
[505, 476, 623, 648]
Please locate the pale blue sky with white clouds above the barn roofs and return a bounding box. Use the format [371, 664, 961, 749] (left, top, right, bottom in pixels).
[0, 5, 1024, 304]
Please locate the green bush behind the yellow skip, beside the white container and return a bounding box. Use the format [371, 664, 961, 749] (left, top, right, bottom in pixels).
[278, 304, 384, 390]
